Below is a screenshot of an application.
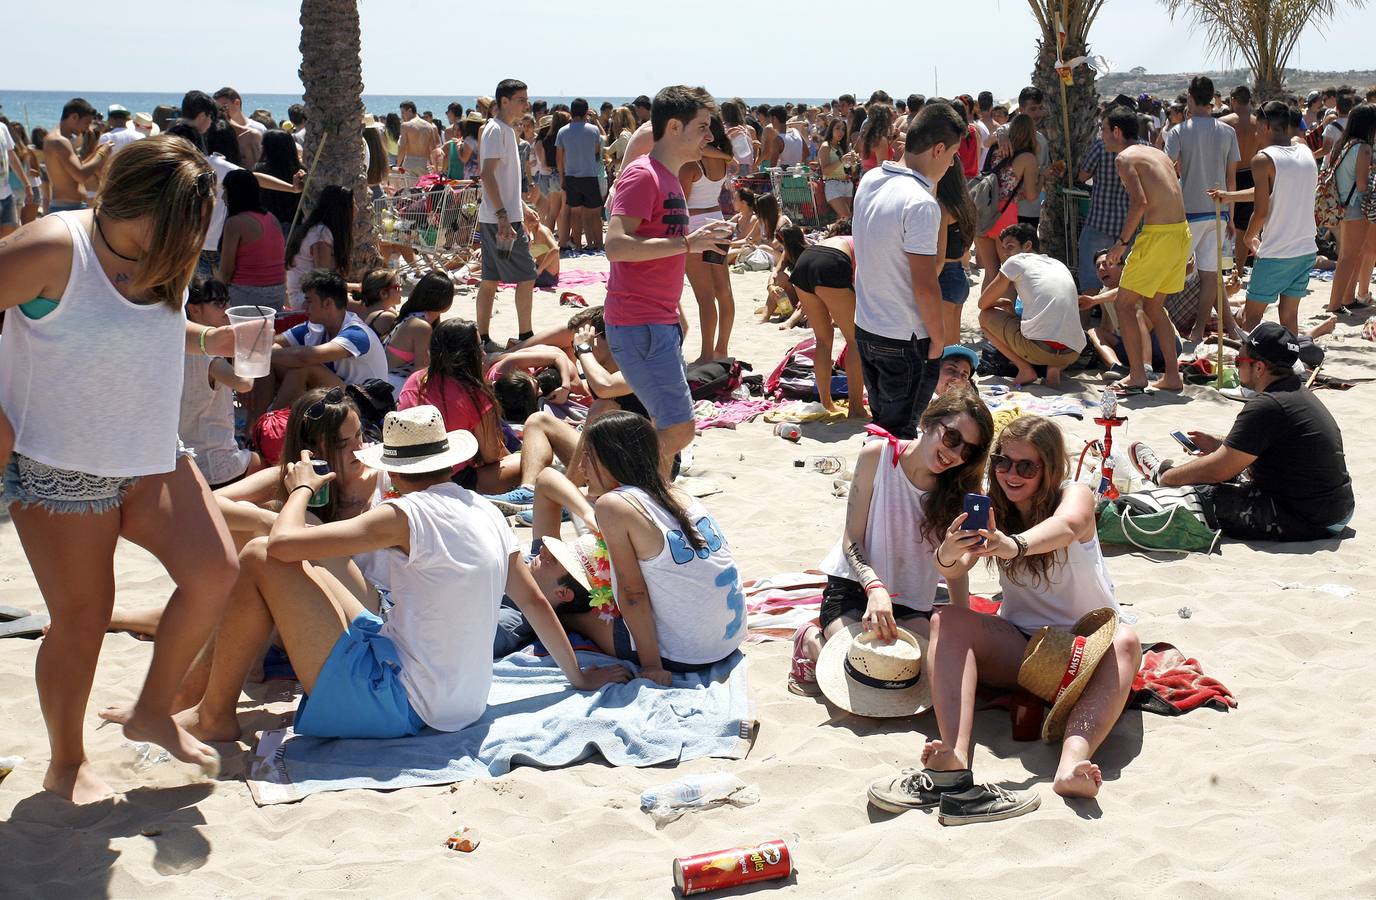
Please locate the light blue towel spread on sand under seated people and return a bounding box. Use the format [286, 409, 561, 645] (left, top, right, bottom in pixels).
[248, 651, 754, 806]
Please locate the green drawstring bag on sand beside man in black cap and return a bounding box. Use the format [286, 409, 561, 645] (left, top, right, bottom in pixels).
[1098, 487, 1222, 553]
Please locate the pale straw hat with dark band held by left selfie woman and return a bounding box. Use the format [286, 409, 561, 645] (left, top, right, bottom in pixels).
[817, 622, 932, 718]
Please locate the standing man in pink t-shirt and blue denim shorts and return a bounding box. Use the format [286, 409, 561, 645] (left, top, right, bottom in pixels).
[604, 85, 733, 473]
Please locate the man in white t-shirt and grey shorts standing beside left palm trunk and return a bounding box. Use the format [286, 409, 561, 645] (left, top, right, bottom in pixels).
[477, 78, 533, 352]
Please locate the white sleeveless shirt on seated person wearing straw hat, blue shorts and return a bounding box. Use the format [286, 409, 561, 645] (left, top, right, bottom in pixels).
[381, 482, 516, 731]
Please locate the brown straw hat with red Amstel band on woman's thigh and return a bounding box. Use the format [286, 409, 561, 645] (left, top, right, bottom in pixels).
[1018, 607, 1117, 740]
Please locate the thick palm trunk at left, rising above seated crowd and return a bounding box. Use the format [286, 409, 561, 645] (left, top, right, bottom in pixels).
[300, 0, 377, 277]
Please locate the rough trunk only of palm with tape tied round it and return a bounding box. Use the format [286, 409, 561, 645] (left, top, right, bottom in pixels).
[1032, 34, 1099, 270]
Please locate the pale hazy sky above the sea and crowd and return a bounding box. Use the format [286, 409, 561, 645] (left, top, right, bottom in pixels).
[0, 0, 1376, 98]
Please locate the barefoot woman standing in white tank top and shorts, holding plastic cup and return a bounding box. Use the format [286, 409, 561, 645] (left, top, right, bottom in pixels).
[0, 136, 238, 802]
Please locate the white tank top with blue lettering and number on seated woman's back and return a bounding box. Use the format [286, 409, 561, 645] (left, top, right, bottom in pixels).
[611, 484, 746, 665]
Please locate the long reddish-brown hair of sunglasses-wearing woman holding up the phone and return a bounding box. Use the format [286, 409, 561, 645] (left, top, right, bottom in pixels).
[989, 416, 1071, 585]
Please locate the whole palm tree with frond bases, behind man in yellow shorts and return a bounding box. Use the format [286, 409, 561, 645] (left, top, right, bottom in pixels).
[1028, 0, 1104, 268]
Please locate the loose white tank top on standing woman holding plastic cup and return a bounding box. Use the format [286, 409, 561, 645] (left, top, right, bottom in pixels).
[0, 212, 186, 478]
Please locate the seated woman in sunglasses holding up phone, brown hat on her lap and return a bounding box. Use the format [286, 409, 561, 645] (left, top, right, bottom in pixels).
[912, 416, 1142, 805]
